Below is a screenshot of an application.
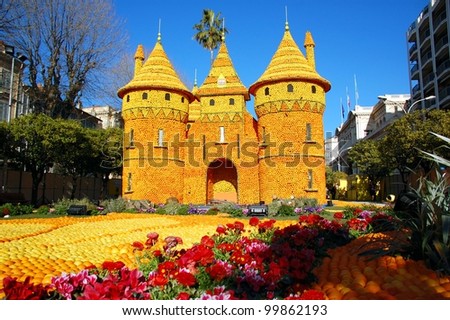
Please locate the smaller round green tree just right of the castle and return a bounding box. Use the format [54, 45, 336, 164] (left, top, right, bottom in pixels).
[348, 139, 390, 196]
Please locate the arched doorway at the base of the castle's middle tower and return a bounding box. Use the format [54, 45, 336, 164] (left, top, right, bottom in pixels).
[206, 158, 238, 203]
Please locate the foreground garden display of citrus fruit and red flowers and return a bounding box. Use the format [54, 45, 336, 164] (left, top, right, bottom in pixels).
[0, 210, 450, 299]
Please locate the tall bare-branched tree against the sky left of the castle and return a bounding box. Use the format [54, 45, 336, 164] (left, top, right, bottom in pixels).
[3, 0, 125, 118]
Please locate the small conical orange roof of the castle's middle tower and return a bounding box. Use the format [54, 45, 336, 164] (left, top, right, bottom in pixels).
[197, 42, 250, 100]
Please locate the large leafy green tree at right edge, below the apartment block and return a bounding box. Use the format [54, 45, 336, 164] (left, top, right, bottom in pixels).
[380, 110, 450, 189]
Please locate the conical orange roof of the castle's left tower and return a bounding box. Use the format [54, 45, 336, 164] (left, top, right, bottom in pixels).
[117, 40, 195, 102]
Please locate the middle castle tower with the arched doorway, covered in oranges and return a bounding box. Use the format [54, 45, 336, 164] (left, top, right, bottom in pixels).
[184, 33, 259, 203]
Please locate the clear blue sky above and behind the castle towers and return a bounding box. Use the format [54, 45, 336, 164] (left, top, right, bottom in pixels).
[114, 0, 429, 132]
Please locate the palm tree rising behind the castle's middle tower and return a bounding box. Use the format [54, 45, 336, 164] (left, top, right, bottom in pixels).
[194, 9, 228, 64]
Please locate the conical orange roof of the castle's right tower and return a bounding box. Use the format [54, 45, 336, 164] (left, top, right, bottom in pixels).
[249, 27, 331, 95]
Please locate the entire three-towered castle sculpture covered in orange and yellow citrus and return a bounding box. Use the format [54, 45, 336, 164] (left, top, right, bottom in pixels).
[118, 23, 331, 204]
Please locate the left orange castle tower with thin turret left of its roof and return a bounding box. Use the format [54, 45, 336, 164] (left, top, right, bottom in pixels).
[118, 34, 194, 203]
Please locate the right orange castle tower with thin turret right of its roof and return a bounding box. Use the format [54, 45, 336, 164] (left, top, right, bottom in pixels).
[249, 22, 331, 203]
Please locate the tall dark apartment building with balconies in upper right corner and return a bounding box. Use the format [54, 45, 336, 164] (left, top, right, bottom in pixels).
[406, 0, 450, 109]
